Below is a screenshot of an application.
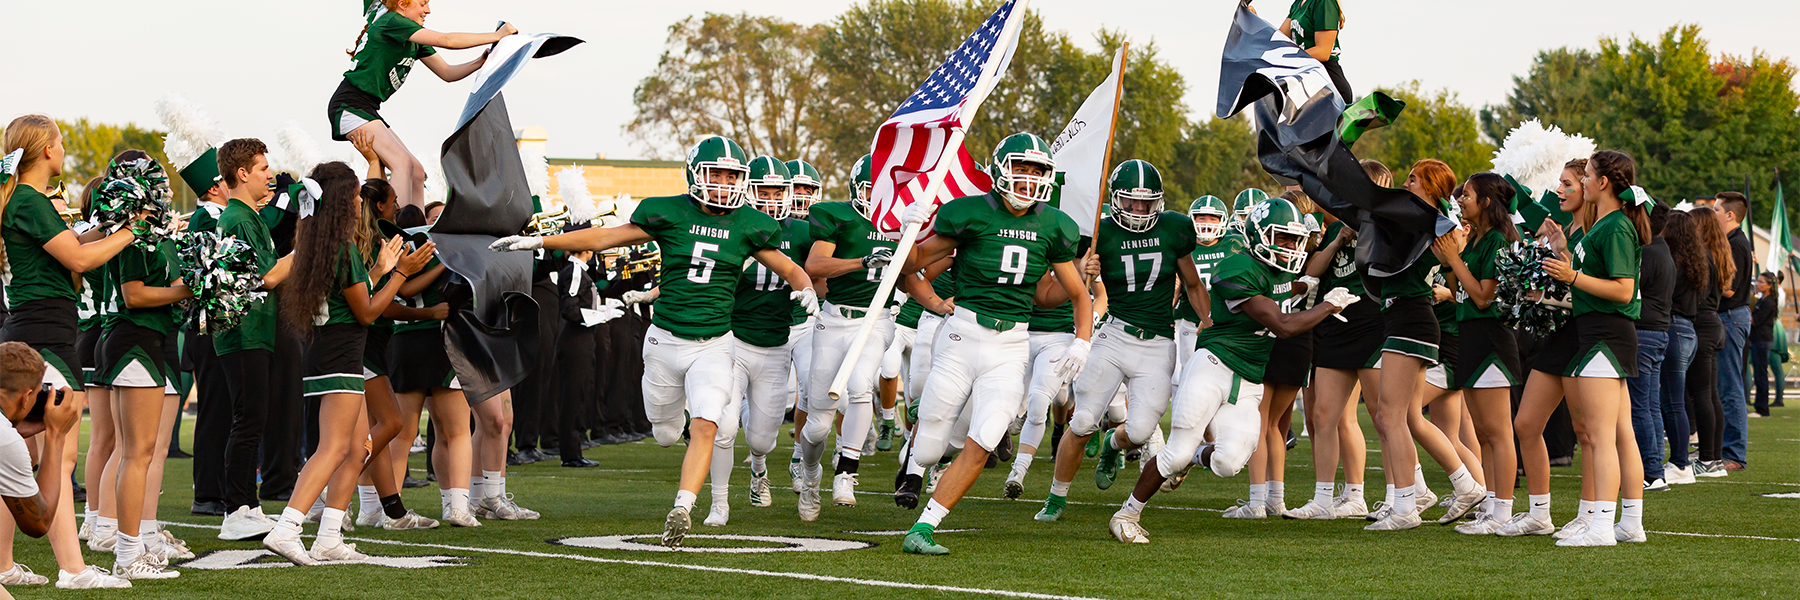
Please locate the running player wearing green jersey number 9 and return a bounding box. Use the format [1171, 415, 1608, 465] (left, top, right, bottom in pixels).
[902, 133, 1094, 555]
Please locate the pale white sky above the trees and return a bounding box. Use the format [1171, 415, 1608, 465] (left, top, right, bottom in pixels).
[0, 0, 1800, 181]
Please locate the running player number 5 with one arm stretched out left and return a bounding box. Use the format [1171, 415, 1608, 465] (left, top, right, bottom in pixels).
[490, 135, 819, 548]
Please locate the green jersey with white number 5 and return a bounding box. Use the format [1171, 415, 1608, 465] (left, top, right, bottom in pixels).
[632, 195, 781, 339]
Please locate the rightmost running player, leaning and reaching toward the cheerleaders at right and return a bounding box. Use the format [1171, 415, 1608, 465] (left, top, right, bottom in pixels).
[1109, 198, 1357, 544]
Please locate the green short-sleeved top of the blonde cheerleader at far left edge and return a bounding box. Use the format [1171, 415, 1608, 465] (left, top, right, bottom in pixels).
[0, 184, 77, 310]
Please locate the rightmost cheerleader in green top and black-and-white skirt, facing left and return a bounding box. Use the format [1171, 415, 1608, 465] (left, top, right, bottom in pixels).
[1544, 150, 1651, 546]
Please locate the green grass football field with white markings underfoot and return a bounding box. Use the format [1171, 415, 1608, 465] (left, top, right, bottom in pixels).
[11, 400, 1800, 600]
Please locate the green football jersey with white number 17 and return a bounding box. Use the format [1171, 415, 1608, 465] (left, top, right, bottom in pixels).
[1094, 211, 1195, 337]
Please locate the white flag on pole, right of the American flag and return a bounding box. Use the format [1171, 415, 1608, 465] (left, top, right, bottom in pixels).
[1049, 47, 1125, 236]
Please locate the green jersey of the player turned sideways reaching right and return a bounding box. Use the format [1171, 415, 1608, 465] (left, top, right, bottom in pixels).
[1195, 254, 1294, 384]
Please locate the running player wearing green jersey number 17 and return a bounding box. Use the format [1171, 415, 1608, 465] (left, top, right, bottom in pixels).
[1037, 159, 1208, 521]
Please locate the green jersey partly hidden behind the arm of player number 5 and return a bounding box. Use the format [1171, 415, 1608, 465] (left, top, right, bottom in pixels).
[731, 218, 812, 348]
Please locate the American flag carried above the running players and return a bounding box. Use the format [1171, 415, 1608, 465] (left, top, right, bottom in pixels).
[869, 0, 1026, 238]
